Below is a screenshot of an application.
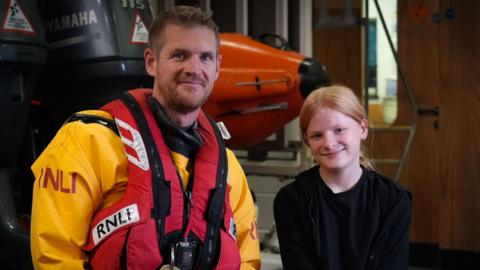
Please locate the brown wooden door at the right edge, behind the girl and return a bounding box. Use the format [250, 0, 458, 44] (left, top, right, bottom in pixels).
[398, 0, 480, 252]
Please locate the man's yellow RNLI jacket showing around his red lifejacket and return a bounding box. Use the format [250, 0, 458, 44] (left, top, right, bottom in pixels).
[30, 110, 260, 269]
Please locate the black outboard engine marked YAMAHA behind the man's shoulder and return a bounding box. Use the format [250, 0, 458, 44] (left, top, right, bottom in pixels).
[38, 0, 153, 137]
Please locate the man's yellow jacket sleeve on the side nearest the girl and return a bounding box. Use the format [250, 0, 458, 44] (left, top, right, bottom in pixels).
[227, 150, 260, 270]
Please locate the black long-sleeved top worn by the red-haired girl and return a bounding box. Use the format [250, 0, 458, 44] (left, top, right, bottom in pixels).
[274, 166, 411, 270]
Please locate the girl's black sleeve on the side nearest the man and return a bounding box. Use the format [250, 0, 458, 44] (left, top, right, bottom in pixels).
[273, 186, 318, 270]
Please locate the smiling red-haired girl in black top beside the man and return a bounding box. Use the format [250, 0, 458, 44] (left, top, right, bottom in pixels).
[274, 85, 411, 270]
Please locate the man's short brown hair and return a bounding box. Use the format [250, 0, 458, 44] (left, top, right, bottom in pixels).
[148, 6, 220, 53]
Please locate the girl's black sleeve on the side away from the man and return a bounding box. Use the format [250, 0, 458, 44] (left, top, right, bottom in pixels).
[374, 191, 412, 270]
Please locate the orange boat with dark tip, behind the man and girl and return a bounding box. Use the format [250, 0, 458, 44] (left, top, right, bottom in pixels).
[203, 34, 329, 148]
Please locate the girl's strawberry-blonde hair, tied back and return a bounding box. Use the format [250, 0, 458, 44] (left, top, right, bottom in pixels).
[299, 85, 373, 169]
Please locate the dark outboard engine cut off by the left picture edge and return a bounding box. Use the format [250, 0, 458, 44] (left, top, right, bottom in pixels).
[0, 0, 47, 269]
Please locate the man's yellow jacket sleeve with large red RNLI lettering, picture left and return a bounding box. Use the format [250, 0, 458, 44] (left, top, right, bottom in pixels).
[30, 110, 126, 269]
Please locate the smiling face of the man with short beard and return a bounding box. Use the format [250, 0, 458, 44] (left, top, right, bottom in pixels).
[145, 24, 221, 114]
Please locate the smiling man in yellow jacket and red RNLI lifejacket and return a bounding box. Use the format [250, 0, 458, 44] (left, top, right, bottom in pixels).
[31, 6, 260, 269]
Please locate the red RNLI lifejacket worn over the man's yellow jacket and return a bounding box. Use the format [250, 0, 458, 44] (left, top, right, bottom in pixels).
[84, 89, 240, 270]
